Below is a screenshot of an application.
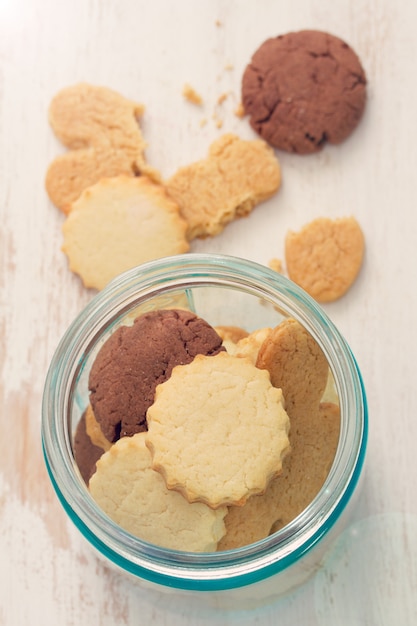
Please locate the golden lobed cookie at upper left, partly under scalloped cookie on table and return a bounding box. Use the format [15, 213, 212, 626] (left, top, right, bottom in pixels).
[45, 83, 159, 213]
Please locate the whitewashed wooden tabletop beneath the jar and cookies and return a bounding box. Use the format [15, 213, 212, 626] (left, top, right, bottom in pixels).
[0, 0, 417, 626]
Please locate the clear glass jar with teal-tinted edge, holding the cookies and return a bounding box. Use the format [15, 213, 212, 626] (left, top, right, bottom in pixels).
[42, 254, 367, 608]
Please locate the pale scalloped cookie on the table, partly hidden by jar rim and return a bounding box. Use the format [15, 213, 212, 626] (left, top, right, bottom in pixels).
[62, 176, 189, 289]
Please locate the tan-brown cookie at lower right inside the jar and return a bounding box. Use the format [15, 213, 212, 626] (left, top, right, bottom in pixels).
[218, 403, 340, 550]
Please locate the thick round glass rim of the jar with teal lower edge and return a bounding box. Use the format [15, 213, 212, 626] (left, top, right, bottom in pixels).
[42, 253, 368, 591]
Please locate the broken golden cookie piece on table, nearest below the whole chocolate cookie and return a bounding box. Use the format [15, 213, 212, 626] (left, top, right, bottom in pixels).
[166, 134, 281, 239]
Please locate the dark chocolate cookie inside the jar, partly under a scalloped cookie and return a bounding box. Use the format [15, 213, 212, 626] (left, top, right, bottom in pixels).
[89, 309, 224, 442]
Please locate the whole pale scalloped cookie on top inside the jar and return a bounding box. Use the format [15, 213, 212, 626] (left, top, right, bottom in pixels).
[146, 352, 289, 508]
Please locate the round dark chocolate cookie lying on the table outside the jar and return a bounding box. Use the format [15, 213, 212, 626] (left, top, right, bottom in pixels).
[242, 30, 366, 154]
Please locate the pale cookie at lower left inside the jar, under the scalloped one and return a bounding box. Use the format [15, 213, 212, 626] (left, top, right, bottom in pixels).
[89, 433, 227, 552]
